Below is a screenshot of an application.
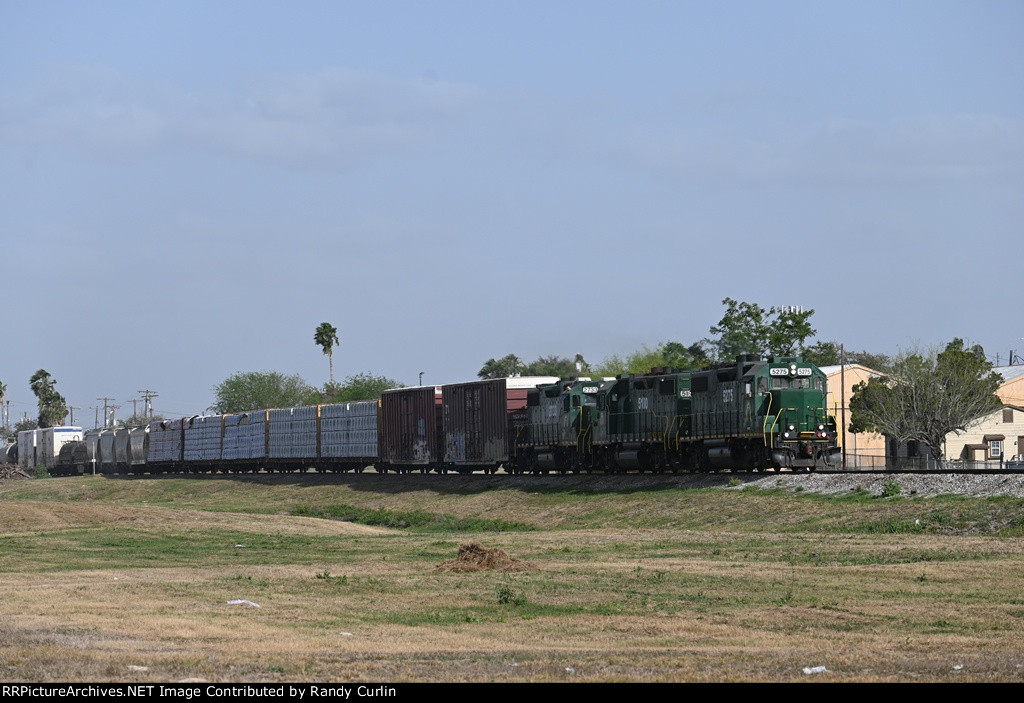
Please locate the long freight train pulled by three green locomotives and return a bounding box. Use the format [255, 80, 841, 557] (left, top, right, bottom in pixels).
[18, 355, 840, 475]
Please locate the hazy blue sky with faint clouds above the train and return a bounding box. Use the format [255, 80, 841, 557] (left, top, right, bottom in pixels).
[0, 0, 1024, 426]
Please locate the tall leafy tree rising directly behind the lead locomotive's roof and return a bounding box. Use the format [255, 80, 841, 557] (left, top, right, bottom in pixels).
[707, 298, 815, 361]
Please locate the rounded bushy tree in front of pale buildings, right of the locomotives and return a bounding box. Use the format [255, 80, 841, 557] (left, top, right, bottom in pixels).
[850, 338, 1002, 459]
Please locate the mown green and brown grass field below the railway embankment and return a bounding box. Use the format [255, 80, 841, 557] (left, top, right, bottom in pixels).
[0, 474, 1024, 683]
